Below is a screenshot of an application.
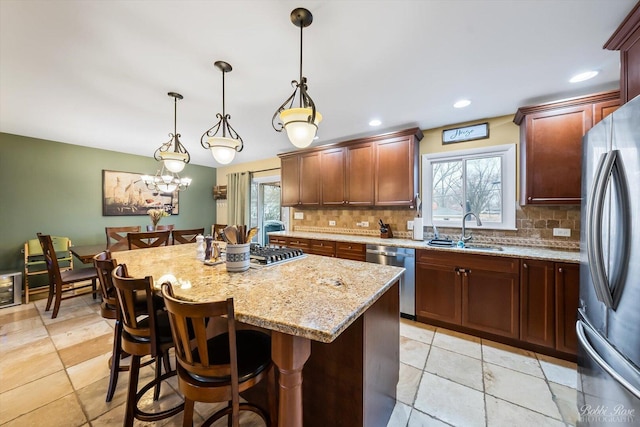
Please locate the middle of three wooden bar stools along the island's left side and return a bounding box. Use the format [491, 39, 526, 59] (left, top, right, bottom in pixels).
[111, 264, 184, 426]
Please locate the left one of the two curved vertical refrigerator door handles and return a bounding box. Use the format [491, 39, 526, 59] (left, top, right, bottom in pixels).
[586, 152, 614, 308]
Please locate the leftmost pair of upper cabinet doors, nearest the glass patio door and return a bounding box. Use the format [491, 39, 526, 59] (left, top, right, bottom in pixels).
[280, 152, 321, 206]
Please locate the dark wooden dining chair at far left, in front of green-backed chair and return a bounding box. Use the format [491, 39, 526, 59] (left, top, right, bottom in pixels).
[38, 233, 98, 319]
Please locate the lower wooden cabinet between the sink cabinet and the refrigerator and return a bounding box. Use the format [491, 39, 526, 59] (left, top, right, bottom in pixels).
[520, 259, 580, 355]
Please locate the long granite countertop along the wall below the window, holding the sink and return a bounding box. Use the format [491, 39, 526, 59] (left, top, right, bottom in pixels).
[269, 231, 580, 263]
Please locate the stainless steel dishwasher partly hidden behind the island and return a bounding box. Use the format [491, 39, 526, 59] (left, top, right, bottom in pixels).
[367, 245, 416, 320]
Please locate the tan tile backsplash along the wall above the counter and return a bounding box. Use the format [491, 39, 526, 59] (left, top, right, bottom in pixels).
[291, 206, 580, 250]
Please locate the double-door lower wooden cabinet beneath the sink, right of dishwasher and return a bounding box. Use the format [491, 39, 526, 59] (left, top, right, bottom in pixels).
[416, 250, 520, 338]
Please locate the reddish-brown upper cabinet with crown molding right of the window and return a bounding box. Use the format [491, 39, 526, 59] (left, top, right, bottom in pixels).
[513, 91, 620, 205]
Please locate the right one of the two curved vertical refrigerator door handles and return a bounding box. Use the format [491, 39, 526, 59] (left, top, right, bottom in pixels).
[609, 150, 632, 310]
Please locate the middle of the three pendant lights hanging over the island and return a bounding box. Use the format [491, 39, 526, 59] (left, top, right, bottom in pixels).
[200, 61, 244, 165]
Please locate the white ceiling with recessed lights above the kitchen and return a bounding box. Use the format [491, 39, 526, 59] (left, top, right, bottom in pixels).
[0, 0, 636, 167]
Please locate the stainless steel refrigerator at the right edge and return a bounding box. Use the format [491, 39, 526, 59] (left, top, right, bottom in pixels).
[568, 96, 640, 426]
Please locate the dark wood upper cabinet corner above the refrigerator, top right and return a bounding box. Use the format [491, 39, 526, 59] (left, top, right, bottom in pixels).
[604, 3, 640, 104]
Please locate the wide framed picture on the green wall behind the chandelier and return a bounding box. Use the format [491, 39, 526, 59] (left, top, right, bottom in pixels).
[102, 170, 180, 216]
